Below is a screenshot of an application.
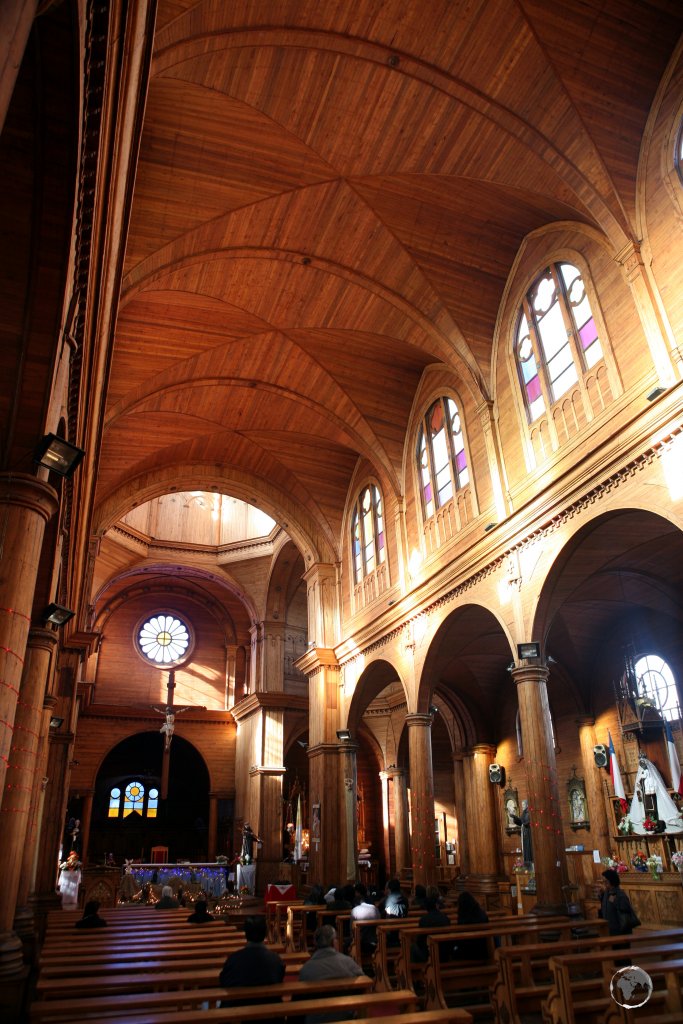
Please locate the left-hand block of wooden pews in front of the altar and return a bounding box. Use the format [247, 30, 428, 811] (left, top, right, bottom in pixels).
[29, 907, 472, 1024]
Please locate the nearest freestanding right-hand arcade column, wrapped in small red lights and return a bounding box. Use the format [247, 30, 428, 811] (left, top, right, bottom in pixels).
[511, 665, 567, 912]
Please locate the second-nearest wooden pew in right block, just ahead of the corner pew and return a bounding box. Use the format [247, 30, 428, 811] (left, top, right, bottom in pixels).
[492, 921, 681, 1024]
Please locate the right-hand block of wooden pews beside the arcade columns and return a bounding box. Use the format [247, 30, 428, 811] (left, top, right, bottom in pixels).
[270, 901, 683, 1024]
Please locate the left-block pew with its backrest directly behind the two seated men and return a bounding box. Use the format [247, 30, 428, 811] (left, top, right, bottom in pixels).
[30, 975, 373, 1024]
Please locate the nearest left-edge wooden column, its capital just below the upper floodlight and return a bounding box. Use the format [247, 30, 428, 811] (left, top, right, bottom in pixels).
[0, 473, 57, 798]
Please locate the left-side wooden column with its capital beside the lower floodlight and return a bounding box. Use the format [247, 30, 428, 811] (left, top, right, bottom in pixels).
[0, 627, 57, 973]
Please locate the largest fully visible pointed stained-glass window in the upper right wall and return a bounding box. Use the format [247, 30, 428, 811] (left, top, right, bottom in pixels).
[515, 263, 602, 423]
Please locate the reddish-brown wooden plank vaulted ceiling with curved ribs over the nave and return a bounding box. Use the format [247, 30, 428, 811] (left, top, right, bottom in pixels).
[97, 0, 683, 555]
